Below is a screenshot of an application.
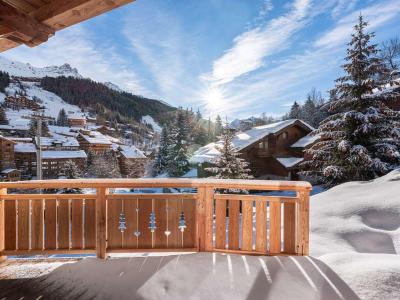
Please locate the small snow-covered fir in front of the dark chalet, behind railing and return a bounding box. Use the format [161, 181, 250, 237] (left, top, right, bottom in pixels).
[206, 126, 252, 179]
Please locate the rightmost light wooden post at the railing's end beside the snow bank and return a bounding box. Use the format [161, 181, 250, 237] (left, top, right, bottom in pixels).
[297, 190, 310, 255]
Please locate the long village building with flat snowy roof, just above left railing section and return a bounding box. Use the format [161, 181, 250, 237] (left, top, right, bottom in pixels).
[42, 150, 87, 178]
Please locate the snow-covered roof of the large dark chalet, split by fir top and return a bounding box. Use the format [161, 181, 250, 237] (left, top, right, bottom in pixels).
[189, 119, 314, 164]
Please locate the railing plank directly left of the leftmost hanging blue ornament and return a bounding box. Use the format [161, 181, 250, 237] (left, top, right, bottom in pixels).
[107, 199, 122, 249]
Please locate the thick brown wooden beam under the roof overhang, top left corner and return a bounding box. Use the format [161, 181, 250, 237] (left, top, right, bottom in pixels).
[0, 0, 55, 47]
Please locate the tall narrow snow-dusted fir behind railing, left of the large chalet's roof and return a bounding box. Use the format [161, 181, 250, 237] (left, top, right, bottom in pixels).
[167, 109, 190, 177]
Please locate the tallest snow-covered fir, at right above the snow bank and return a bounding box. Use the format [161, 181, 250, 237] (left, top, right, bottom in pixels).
[303, 16, 400, 186]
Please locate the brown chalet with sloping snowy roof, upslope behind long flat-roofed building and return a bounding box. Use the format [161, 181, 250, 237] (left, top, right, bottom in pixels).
[77, 129, 112, 153]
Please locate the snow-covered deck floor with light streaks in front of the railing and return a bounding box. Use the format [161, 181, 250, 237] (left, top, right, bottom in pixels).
[0, 253, 359, 300]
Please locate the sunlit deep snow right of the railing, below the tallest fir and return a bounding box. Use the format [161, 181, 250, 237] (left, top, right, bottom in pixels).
[310, 170, 400, 300]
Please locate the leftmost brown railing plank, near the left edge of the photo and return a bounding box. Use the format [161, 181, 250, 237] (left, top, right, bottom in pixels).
[4, 200, 17, 250]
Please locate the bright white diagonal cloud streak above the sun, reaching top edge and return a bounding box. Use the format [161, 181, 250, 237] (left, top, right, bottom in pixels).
[206, 0, 311, 84]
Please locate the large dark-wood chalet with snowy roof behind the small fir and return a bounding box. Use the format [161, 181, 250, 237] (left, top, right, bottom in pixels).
[190, 119, 314, 180]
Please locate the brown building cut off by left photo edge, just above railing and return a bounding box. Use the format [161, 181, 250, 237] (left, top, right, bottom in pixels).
[0, 135, 21, 181]
